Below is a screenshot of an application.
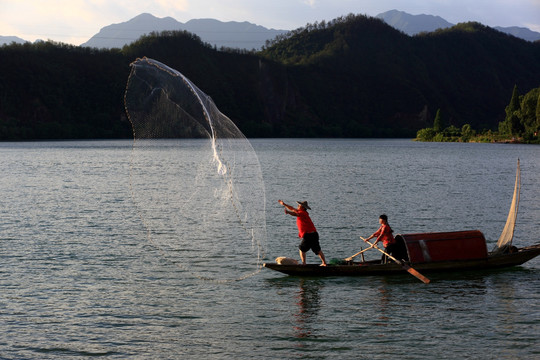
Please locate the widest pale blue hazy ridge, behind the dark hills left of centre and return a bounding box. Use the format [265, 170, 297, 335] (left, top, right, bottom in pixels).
[81, 13, 287, 50]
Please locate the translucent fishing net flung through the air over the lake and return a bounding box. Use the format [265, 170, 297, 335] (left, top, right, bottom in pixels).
[125, 58, 266, 281]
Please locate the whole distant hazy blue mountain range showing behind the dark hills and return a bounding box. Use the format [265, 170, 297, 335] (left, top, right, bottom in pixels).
[0, 10, 540, 50]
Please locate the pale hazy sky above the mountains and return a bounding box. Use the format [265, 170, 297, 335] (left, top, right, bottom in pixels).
[0, 0, 540, 45]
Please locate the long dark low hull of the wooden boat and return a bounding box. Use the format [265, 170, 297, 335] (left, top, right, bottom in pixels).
[263, 244, 540, 276]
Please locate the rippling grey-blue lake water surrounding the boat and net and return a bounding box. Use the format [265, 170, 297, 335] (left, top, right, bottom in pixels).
[0, 139, 540, 359]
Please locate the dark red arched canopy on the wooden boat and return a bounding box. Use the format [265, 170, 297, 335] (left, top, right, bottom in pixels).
[396, 230, 488, 263]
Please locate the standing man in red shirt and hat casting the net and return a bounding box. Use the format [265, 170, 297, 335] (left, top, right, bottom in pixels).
[278, 200, 326, 266]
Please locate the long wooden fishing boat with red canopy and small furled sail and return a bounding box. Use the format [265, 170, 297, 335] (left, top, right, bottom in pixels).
[263, 160, 540, 276]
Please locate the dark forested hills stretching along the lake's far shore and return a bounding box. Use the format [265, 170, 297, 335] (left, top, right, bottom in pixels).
[0, 15, 540, 139]
